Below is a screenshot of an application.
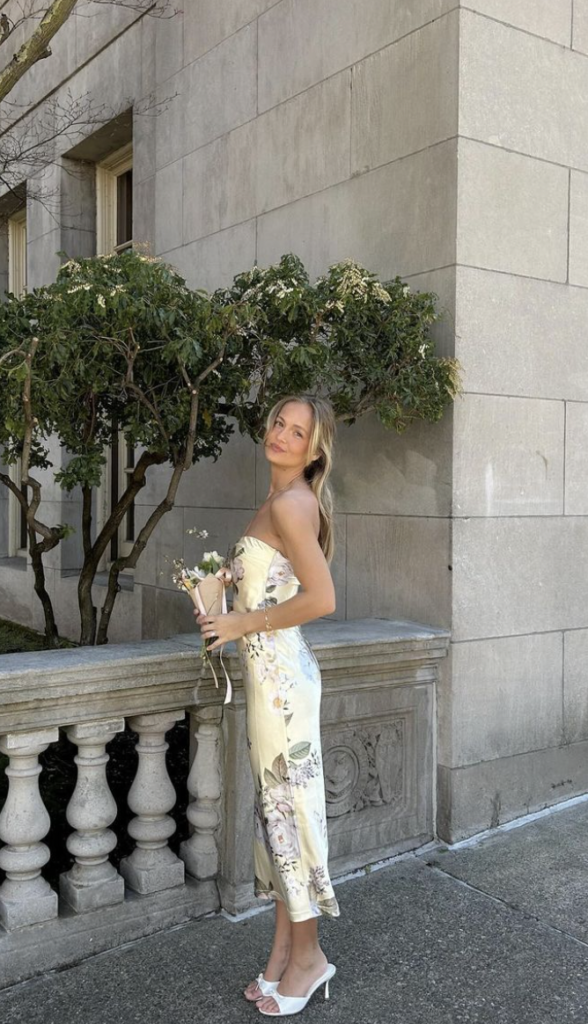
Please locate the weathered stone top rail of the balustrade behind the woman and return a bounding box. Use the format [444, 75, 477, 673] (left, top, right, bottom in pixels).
[0, 618, 449, 734]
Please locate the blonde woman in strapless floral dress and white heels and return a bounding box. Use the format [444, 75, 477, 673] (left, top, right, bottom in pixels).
[198, 395, 339, 1016]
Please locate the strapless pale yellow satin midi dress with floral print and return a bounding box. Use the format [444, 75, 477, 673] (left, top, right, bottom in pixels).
[230, 536, 339, 922]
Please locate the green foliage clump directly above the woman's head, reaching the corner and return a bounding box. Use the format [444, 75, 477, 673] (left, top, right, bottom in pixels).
[216, 255, 460, 433]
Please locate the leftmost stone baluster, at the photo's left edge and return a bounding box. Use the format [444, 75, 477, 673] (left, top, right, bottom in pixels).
[0, 726, 59, 931]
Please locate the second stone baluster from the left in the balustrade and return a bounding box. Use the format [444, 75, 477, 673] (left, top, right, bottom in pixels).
[59, 719, 125, 912]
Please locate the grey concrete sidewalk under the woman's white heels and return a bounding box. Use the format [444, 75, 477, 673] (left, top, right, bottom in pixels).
[0, 802, 588, 1024]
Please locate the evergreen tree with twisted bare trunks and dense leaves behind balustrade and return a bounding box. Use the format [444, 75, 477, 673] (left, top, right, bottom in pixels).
[0, 252, 460, 644]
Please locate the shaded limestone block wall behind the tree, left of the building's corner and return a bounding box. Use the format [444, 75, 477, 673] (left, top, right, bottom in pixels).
[0, 0, 459, 640]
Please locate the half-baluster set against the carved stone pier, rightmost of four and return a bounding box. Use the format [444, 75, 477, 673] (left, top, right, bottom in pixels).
[179, 707, 222, 881]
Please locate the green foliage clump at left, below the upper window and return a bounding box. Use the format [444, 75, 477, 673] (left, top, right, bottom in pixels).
[0, 252, 254, 490]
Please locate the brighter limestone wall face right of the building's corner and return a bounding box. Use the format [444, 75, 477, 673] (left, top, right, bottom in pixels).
[438, 0, 588, 840]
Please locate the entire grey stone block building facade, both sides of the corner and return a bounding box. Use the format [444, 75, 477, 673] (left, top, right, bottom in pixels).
[0, 0, 588, 841]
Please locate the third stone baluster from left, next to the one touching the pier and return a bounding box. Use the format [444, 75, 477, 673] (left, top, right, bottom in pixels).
[120, 711, 185, 894]
